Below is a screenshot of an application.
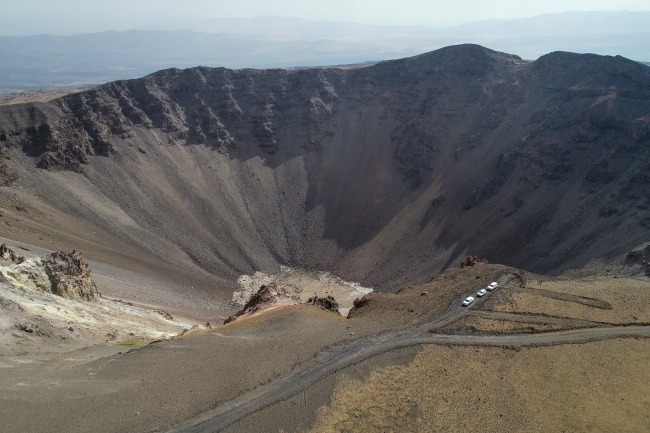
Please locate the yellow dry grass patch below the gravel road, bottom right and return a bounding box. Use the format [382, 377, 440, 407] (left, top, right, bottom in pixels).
[311, 339, 650, 433]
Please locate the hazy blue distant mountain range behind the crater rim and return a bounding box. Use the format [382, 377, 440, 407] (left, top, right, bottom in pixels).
[0, 12, 650, 91]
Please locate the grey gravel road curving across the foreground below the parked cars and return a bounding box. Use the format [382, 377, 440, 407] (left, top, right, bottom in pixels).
[169, 318, 650, 433]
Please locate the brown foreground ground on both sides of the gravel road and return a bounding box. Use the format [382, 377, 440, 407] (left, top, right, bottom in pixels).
[0, 265, 650, 432]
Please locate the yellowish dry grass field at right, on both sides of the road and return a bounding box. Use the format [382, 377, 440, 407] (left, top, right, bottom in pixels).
[302, 266, 650, 433]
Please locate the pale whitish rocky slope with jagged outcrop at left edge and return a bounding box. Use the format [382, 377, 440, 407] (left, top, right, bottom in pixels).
[0, 248, 194, 367]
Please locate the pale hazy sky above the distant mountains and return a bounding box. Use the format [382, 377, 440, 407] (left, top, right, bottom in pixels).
[0, 0, 650, 35]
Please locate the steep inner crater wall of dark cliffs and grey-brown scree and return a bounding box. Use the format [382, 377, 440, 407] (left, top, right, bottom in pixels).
[0, 45, 650, 290]
